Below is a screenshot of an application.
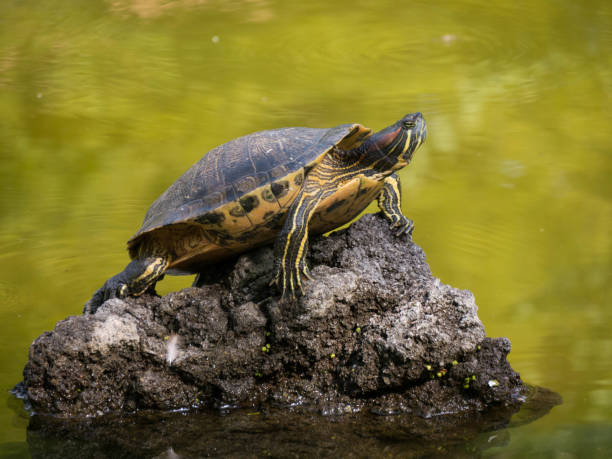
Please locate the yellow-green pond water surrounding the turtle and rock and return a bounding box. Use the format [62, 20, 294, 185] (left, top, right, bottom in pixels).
[0, 0, 612, 457]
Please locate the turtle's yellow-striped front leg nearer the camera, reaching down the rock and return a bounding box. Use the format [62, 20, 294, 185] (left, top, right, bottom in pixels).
[271, 181, 333, 299]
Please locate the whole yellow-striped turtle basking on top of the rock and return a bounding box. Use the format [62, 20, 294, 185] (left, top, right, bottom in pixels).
[84, 112, 427, 313]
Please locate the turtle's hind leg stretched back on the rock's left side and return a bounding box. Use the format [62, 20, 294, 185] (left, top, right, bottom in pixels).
[83, 257, 169, 314]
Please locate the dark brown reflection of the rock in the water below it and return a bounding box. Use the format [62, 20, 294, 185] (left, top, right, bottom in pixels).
[28, 388, 560, 458]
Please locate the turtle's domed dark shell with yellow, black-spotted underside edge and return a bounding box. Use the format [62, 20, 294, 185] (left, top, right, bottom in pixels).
[128, 124, 371, 272]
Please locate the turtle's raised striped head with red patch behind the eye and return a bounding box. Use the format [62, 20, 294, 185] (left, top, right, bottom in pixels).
[371, 112, 427, 169]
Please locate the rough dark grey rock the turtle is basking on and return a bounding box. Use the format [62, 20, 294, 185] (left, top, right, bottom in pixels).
[23, 215, 525, 416]
